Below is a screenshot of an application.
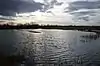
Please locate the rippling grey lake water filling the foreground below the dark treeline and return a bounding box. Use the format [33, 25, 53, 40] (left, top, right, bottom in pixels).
[0, 29, 100, 66]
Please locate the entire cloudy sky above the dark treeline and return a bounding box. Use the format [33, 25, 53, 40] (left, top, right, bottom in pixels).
[0, 0, 100, 25]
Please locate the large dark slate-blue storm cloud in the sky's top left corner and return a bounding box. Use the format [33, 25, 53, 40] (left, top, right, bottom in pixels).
[0, 0, 43, 16]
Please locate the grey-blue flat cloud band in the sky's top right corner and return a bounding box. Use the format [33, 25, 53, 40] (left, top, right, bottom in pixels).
[68, 1, 100, 11]
